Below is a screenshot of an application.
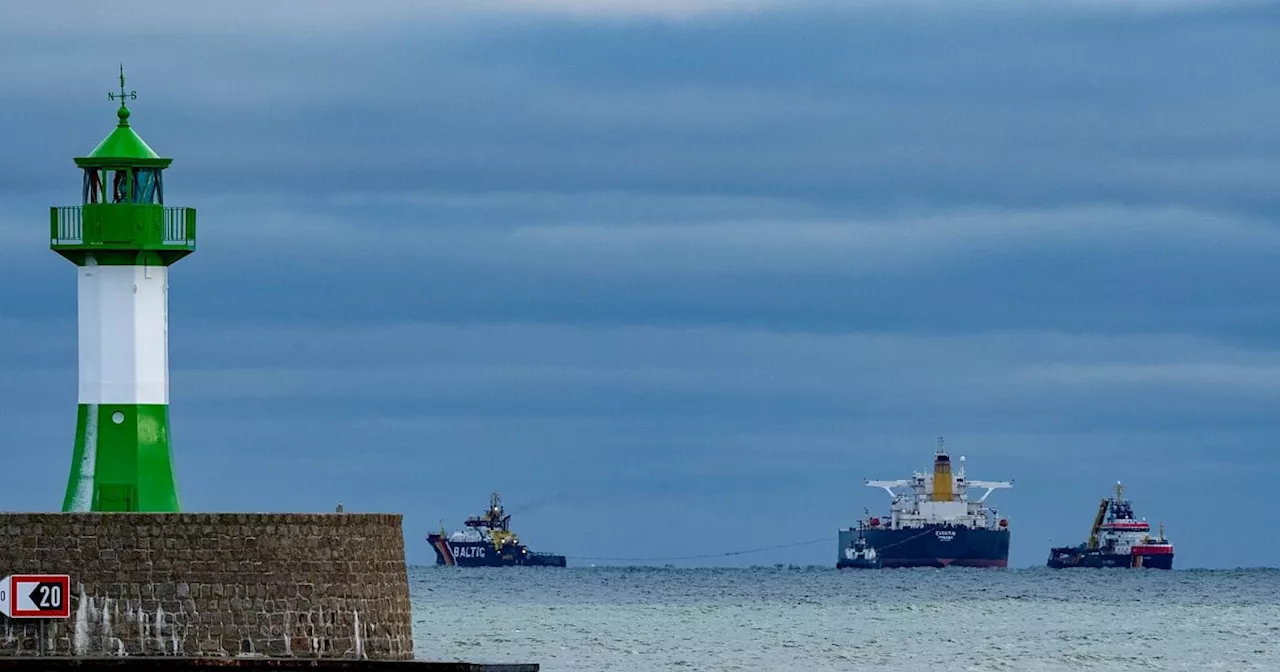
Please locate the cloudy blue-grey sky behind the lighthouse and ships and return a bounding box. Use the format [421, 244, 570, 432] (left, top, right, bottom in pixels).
[0, 0, 1280, 567]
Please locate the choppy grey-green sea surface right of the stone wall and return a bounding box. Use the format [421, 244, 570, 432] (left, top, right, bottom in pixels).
[410, 567, 1280, 672]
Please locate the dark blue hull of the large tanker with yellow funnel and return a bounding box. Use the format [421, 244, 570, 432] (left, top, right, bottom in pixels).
[836, 525, 1010, 567]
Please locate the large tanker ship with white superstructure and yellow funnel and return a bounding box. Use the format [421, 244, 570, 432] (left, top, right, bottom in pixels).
[836, 438, 1014, 567]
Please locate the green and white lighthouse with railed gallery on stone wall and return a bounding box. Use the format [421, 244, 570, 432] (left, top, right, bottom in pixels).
[50, 67, 196, 512]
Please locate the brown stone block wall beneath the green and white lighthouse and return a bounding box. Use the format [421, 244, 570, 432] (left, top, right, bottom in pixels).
[0, 513, 413, 659]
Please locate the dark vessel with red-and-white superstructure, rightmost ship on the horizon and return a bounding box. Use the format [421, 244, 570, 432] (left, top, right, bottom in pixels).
[1048, 481, 1174, 570]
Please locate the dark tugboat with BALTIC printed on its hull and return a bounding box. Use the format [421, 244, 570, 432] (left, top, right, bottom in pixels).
[426, 493, 566, 567]
